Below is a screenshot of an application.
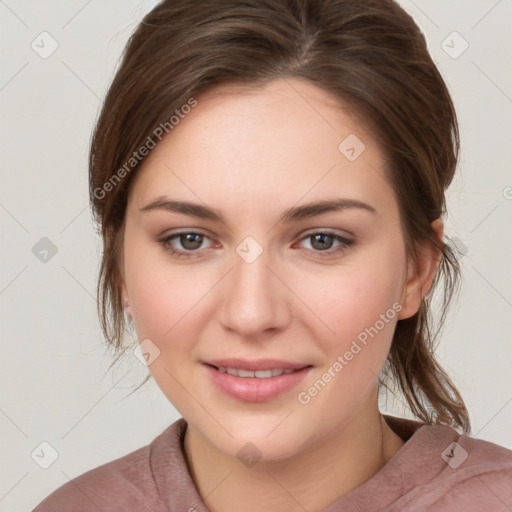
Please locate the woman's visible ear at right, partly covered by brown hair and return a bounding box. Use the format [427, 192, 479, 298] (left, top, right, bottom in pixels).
[398, 219, 444, 320]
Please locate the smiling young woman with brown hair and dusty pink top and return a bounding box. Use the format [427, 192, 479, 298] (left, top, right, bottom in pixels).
[35, 0, 512, 512]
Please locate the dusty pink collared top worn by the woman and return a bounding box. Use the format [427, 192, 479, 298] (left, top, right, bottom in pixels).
[33, 415, 512, 512]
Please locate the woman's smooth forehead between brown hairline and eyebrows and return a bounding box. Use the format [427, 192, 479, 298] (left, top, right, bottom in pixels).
[125, 79, 393, 222]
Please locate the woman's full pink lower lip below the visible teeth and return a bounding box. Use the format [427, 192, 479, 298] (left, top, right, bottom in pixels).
[204, 364, 312, 402]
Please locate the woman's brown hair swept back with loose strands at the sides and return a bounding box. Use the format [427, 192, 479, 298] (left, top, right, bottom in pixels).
[89, 0, 470, 432]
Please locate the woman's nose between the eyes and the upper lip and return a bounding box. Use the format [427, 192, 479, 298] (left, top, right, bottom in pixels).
[219, 245, 292, 338]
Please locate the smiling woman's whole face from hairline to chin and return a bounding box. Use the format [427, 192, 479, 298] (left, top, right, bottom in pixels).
[123, 79, 424, 459]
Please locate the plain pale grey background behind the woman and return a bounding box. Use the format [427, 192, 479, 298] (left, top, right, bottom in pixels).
[0, 0, 512, 512]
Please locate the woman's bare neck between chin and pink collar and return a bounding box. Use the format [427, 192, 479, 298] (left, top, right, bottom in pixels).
[185, 397, 404, 512]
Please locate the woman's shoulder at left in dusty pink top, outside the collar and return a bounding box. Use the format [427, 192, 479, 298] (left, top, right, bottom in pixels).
[33, 425, 179, 512]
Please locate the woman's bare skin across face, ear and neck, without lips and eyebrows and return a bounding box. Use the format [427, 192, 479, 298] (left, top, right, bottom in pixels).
[121, 79, 443, 512]
